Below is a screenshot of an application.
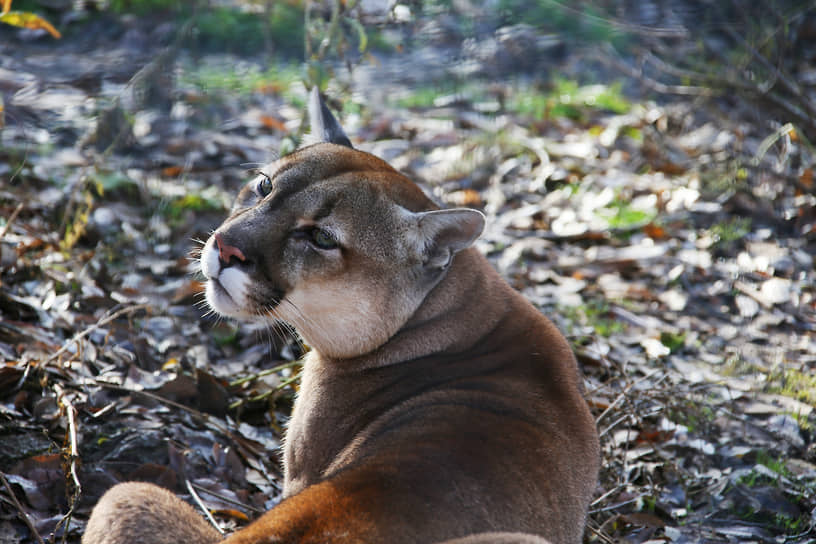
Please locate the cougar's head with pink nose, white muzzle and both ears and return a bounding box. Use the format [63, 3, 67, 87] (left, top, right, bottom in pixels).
[201, 89, 484, 358]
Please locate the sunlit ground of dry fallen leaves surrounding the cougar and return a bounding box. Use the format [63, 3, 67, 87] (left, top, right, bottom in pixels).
[0, 7, 816, 543]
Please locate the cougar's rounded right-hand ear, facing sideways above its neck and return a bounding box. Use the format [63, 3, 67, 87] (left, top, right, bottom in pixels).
[417, 208, 485, 269]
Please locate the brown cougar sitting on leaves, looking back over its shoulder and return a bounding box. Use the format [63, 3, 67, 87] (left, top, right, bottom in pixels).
[83, 90, 599, 544]
